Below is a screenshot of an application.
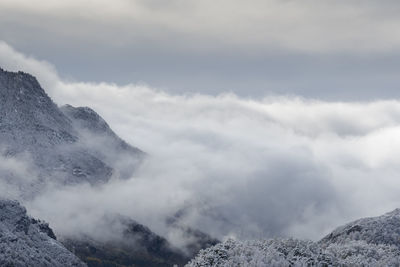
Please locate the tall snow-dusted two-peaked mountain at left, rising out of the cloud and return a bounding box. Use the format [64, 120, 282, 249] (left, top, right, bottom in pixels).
[0, 69, 144, 196]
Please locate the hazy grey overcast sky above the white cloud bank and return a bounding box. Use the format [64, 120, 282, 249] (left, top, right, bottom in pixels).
[0, 0, 400, 101]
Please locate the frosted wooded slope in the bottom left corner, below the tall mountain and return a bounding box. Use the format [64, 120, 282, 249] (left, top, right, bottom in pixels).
[0, 200, 85, 267]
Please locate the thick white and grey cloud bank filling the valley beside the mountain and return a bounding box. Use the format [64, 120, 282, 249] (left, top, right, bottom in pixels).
[0, 43, 400, 247]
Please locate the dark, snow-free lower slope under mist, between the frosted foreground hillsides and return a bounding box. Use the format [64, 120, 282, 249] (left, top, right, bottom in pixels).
[61, 215, 189, 267]
